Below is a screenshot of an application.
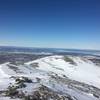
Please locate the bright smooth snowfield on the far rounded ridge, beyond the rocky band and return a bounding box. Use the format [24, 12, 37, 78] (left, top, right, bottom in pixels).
[26, 56, 100, 88]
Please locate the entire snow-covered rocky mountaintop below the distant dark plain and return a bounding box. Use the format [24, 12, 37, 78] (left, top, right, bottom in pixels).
[0, 55, 100, 100]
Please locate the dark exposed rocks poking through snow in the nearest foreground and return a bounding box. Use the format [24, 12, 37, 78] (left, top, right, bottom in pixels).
[4, 77, 77, 100]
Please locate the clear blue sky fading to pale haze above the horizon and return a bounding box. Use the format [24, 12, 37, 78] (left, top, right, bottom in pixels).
[0, 0, 100, 49]
